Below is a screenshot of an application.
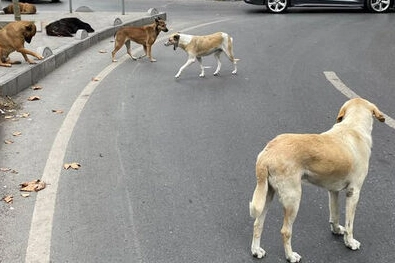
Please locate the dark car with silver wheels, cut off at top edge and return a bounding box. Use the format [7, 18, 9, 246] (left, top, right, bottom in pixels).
[244, 0, 395, 13]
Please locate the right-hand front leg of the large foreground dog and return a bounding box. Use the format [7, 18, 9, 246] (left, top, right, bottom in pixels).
[344, 187, 361, 250]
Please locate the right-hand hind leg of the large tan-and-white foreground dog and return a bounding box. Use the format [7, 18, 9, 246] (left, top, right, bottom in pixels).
[278, 183, 302, 263]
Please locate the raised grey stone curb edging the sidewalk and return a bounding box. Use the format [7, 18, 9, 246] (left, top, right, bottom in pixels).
[0, 13, 166, 97]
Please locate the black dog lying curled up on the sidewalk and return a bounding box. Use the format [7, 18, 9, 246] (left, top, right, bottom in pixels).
[45, 17, 95, 37]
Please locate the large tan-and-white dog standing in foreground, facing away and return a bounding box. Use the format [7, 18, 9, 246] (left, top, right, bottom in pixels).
[250, 98, 385, 262]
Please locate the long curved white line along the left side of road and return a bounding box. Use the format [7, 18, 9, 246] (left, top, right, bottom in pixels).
[25, 18, 230, 263]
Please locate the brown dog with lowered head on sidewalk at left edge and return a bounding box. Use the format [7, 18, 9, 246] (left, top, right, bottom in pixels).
[0, 21, 43, 67]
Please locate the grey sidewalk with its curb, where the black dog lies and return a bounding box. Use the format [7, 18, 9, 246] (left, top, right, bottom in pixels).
[0, 9, 166, 96]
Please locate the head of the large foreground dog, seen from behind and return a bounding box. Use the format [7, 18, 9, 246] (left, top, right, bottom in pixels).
[337, 98, 385, 122]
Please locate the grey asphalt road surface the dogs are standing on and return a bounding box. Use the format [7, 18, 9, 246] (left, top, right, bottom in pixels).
[0, 0, 395, 263]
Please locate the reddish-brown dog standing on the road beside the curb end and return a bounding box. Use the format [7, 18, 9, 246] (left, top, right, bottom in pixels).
[111, 18, 169, 62]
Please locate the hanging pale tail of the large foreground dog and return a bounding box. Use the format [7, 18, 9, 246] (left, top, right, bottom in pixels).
[250, 156, 269, 218]
